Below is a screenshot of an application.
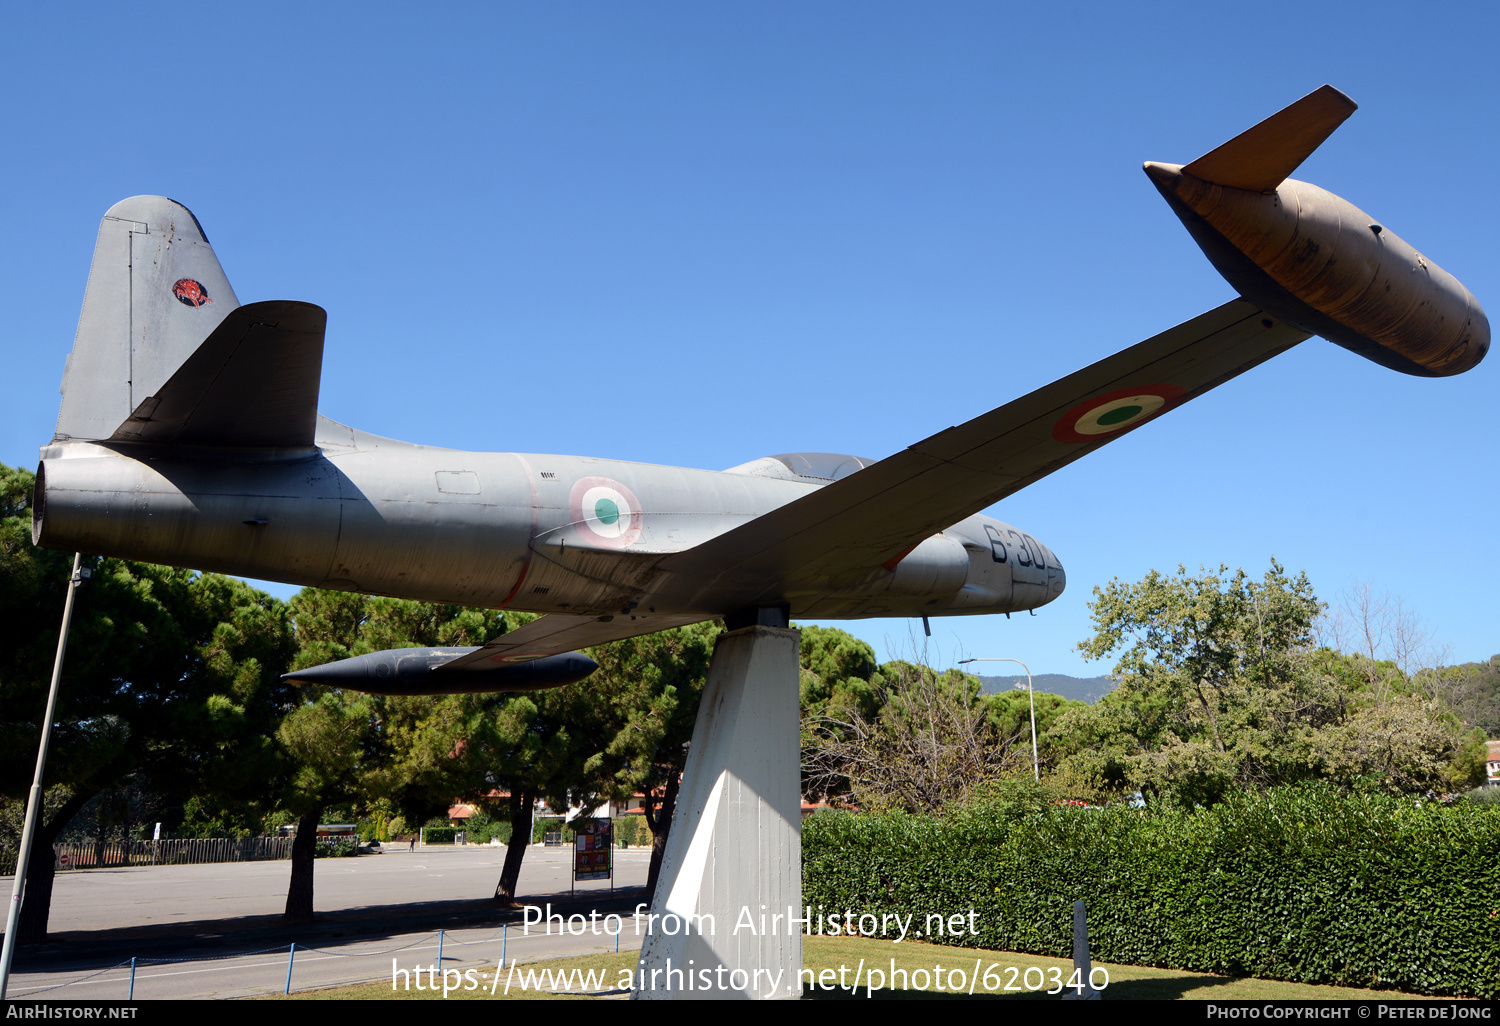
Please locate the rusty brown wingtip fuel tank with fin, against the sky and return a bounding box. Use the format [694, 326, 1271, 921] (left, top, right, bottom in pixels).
[1146, 86, 1490, 377]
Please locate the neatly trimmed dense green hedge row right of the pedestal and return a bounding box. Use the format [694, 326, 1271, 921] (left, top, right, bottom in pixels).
[803, 789, 1500, 998]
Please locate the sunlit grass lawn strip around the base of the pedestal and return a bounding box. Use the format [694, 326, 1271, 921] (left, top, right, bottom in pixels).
[272, 938, 1446, 1001]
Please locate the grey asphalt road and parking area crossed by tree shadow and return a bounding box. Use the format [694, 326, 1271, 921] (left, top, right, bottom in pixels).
[0, 846, 650, 1001]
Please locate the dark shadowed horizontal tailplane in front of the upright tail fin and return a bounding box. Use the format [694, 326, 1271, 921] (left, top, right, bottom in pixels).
[113, 300, 329, 446]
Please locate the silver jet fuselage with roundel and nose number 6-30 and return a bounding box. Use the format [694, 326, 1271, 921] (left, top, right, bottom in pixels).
[33, 420, 1065, 618]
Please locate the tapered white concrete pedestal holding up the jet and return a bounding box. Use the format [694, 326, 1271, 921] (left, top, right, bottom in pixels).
[632, 627, 804, 999]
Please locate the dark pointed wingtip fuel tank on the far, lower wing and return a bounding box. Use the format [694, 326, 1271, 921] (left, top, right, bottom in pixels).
[282, 648, 599, 695]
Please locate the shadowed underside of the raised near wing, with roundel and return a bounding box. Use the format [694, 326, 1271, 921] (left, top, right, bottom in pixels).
[659, 299, 1311, 611]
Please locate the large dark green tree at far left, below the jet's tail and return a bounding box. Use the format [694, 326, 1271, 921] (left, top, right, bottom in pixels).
[0, 468, 293, 942]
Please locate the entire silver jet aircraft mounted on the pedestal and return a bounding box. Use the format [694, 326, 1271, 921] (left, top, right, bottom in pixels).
[33, 86, 1490, 693]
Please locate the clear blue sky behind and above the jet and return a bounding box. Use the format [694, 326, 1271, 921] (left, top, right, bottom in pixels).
[0, 3, 1500, 675]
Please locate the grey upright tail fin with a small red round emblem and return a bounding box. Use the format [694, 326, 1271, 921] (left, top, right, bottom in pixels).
[54, 197, 240, 441]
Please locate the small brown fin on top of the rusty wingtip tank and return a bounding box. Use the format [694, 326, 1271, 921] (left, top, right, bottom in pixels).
[1182, 86, 1359, 192]
